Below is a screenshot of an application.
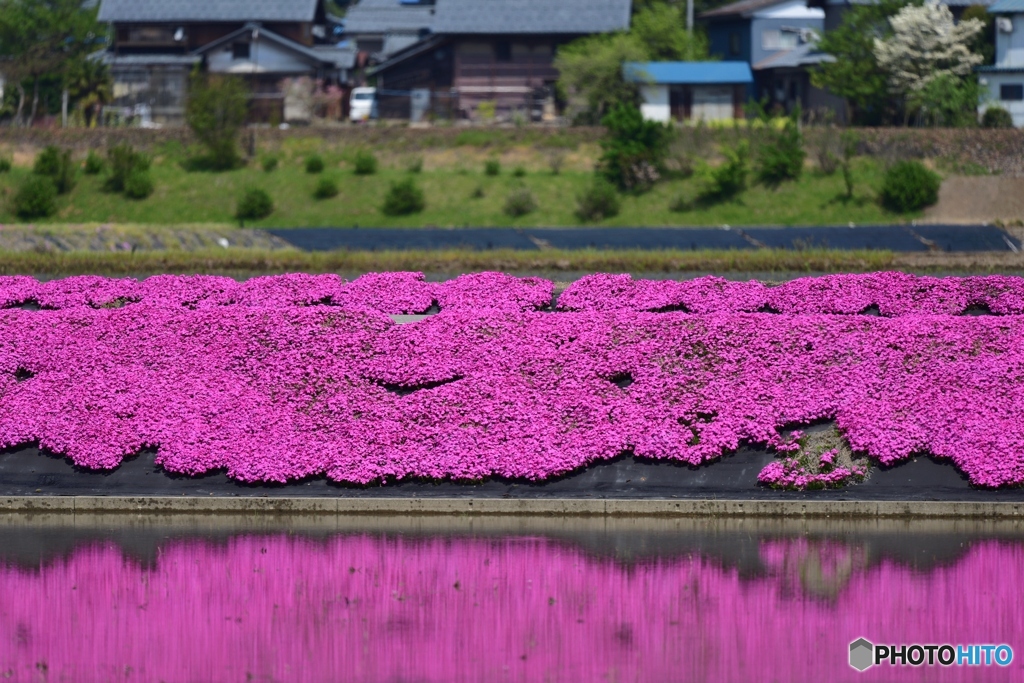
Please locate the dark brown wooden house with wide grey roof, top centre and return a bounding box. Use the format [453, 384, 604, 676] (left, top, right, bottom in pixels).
[368, 0, 632, 120]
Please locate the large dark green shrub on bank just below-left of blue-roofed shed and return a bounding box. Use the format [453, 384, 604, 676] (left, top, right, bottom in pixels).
[599, 103, 674, 190]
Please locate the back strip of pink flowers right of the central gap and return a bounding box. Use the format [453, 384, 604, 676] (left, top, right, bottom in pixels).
[558, 272, 1024, 316]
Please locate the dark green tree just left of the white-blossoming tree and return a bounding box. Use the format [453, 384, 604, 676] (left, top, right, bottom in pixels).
[811, 0, 906, 124]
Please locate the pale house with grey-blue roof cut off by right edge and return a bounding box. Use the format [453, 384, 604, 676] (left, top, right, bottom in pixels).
[977, 0, 1024, 128]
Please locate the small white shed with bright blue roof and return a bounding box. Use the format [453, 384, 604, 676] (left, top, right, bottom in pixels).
[624, 61, 754, 123]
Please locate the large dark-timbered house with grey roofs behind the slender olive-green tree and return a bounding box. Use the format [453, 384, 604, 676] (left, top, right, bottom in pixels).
[97, 0, 354, 124]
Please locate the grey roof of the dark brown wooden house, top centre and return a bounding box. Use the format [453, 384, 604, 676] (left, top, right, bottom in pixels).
[433, 0, 632, 34]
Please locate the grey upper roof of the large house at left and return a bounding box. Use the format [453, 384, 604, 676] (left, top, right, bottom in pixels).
[98, 0, 321, 23]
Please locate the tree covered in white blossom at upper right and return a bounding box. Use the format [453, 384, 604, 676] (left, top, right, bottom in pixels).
[874, 2, 984, 110]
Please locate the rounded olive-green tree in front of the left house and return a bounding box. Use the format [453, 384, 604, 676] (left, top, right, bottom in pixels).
[185, 70, 249, 171]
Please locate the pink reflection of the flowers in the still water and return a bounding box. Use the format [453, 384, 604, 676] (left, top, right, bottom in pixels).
[0, 536, 1024, 682]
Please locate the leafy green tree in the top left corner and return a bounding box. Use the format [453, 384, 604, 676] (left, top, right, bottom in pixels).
[0, 0, 104, 123]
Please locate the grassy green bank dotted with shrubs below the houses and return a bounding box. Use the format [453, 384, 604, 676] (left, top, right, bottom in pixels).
[0, 152, 913, 227]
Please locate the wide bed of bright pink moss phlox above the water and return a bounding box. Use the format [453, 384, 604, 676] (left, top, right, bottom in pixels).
[0, 273, 1024, 486]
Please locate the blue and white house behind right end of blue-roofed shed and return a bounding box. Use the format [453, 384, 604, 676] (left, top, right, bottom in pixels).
[699, 0, 842, 112]
